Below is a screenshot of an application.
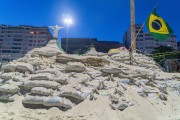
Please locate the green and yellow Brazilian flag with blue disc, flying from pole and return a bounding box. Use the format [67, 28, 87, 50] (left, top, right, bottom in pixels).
[146, 9, 173, 42]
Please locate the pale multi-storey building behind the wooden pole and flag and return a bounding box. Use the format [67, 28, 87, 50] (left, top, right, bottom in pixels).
[123, 24, 177, 53]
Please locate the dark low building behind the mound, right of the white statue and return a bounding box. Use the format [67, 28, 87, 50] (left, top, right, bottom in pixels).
[61, 38, 122, 54]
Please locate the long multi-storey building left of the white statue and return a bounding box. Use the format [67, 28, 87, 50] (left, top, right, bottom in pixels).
[0, 25, 52, 62]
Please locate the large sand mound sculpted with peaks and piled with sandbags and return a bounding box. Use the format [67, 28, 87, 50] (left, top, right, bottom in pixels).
[0, 30, 180, 120]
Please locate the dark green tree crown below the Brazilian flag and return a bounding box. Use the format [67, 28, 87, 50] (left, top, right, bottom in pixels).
[152, 45, 174, 54]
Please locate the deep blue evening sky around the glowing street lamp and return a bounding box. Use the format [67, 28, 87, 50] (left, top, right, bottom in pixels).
[0, 0, 180, 42]
